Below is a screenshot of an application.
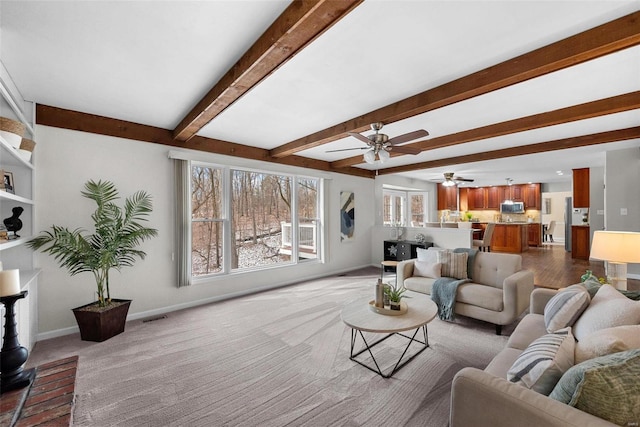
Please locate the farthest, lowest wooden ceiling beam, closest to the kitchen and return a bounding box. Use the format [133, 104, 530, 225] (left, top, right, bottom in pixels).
[378, 126, 640, 175]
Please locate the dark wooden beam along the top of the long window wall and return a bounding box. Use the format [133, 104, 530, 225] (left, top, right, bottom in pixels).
[36, 104, 375, 178]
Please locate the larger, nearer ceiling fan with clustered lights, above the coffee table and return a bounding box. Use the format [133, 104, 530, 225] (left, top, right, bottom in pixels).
[327, 122, 429, 164]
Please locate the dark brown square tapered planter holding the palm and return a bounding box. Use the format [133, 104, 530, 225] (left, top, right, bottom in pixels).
[72, 299, 131, 342]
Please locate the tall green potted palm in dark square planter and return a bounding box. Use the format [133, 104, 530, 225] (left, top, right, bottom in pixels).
[28, 180, 158, 342]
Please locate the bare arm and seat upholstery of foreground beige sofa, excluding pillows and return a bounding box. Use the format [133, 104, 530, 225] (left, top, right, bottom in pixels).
[450, 289, 615, 427]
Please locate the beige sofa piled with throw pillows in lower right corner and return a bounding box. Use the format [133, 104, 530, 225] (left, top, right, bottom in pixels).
[450, 284, 640, 427]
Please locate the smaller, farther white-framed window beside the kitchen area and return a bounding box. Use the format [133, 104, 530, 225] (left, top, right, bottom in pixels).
[382, 189, 428, 227]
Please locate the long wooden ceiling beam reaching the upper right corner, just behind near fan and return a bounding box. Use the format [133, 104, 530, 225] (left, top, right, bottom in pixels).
[271, 11, 640, 157]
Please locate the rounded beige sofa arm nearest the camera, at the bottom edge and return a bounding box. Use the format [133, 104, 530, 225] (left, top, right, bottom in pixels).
[449, 368, 615, 427]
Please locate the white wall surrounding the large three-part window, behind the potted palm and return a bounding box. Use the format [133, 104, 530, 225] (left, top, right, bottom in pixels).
[35, 126, 375, 339]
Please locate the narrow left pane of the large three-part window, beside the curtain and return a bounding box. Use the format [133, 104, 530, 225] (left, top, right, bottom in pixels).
[191, 166, 223, 276]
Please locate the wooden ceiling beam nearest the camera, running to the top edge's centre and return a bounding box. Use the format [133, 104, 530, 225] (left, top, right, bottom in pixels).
[173, 0, 363, 141]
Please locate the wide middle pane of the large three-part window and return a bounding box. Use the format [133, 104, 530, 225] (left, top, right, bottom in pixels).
[231, 171, 291, 269]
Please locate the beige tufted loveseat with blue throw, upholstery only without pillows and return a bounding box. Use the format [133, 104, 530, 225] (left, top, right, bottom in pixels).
[397, 252, 533, 335]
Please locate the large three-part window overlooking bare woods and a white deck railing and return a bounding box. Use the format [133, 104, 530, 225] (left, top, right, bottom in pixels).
[191, 163, 322, 277]
